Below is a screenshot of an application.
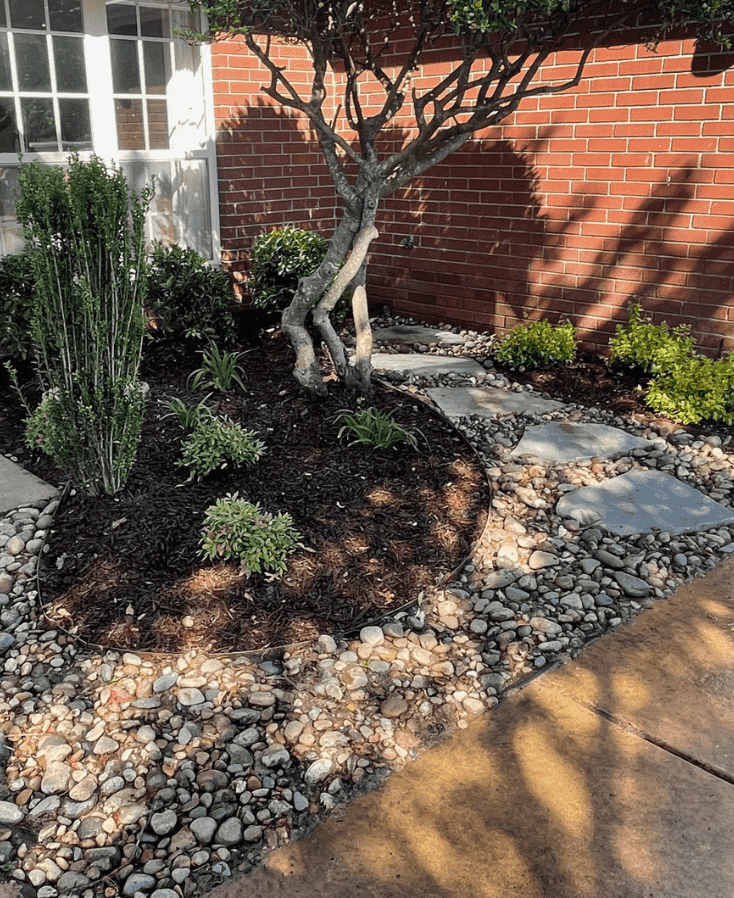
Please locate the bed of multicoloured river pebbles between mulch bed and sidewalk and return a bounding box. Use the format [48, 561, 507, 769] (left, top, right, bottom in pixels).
[0, 320, 734, 898]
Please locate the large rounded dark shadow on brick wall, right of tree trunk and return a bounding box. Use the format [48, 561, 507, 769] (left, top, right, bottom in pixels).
[371, 140, 547, 328]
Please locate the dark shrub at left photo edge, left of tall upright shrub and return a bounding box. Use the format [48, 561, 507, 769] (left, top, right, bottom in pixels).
[0, 252, 35, 360]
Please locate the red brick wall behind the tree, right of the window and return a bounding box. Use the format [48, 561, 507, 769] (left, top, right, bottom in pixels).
[214, 31, 734, 352]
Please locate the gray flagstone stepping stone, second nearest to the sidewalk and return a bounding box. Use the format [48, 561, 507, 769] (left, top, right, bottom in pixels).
[512, 421, 652, 464]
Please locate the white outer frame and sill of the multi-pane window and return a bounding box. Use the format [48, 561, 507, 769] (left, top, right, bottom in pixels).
[0, 0, 221, 262]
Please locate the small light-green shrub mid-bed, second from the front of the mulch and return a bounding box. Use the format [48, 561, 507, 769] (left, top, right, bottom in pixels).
[179, 417, 265, 480]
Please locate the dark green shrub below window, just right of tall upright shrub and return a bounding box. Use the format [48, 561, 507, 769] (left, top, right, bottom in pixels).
[147, 244, 235, 346]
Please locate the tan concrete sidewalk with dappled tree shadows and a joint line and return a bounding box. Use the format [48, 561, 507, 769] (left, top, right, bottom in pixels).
[210, 559, 734, 898]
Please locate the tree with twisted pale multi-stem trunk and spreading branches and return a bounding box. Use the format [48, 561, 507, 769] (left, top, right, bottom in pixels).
[190, 0, 734, 393]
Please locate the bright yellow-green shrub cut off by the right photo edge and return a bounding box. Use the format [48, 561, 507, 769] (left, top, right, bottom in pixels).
[646, 351, 734, 424]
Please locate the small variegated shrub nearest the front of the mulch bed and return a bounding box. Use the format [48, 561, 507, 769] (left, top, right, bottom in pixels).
[201, 493, 301, 573]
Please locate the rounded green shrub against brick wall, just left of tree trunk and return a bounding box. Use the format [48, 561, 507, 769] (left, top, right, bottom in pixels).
[249, 225, 352, 320]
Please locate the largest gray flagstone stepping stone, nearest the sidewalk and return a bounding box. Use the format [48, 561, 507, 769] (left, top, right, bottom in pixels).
[556, 471, 734, 536]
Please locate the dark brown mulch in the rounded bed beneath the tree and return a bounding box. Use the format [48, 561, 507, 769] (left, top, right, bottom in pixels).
[0, 330, 488, 652]
